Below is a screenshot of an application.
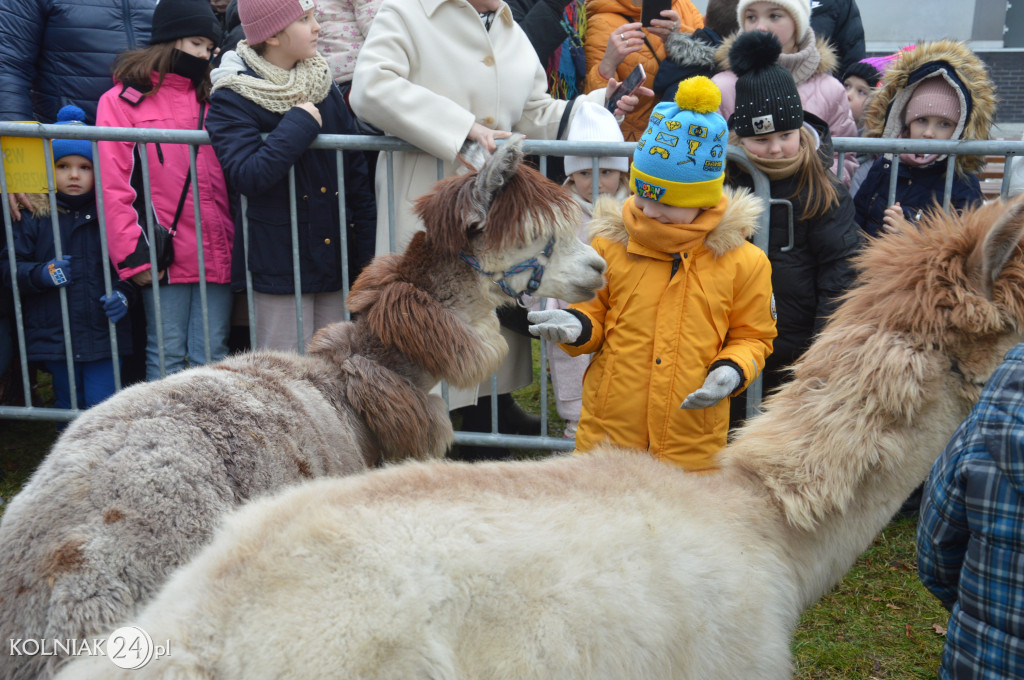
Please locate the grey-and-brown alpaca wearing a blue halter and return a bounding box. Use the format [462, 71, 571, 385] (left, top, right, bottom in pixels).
[0, 138, 604, 679]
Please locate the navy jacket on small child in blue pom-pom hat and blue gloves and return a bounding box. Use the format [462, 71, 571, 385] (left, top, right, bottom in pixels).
[0, 192, 138, 362]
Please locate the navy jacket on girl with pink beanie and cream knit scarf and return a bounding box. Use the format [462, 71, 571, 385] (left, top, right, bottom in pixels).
[206, 69, 377, 295]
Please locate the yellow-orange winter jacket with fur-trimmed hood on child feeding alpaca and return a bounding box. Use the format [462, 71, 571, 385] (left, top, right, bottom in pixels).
[559, 188, 775, 470]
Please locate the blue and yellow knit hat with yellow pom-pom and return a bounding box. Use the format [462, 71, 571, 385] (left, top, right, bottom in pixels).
[630, 76, 729, 208]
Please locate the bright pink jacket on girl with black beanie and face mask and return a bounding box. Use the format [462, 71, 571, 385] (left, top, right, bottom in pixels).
[96, 74, 234, 284]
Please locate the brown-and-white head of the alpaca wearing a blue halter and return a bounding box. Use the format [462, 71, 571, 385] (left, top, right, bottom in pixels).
[416, 135, 605, 304]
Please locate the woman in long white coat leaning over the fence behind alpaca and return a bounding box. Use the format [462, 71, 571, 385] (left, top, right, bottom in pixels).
[349, 0, 638, 440]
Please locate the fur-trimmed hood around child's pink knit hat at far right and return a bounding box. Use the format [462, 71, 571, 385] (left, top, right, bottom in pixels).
[864, 40, 996, 173]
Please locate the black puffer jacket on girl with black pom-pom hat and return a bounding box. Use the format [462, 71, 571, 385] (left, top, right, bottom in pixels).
[727, 112, 864, 389]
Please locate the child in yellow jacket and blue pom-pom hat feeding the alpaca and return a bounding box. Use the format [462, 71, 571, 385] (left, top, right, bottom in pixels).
[529, 77, 775, 470]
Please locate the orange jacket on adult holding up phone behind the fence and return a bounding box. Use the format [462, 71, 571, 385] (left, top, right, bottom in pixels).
[584, 0, 703, 141]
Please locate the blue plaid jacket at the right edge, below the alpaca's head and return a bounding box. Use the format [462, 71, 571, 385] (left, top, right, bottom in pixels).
[918, 343, 1024, 680]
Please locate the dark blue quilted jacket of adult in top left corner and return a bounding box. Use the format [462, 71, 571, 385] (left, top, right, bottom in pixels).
[0, 0, 157, 125]
